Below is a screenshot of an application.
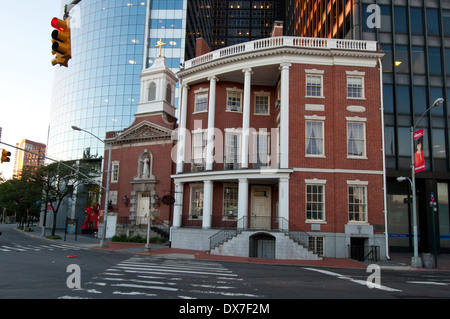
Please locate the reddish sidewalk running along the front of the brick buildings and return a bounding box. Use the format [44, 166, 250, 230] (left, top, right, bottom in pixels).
[29, 227, 450, 271]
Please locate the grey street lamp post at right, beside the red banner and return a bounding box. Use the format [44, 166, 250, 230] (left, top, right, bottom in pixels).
[397, 98, 444, 268]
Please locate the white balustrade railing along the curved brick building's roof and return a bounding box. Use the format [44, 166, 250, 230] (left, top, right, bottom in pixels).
[184, 37, 377, 69]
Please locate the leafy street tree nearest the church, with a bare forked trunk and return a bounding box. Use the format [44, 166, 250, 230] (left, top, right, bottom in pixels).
[26, 160, 100, 236]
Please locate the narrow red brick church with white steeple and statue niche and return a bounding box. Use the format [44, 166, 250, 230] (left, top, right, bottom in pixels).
[103, 57, 177, 237]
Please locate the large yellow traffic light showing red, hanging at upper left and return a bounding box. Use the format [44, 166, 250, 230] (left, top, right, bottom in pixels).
[51, 18, 72, 67]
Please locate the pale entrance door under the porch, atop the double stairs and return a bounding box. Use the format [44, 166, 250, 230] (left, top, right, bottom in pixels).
[250, 186, 271, 230]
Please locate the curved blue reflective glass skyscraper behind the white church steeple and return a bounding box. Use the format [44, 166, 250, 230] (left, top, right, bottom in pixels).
[48, 0, 187, 160]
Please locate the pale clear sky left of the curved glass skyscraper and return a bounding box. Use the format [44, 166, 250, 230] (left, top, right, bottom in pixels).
[0, 0, 62, 179]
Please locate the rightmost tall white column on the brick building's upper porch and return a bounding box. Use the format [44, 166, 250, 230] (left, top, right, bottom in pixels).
[280, 63, 291, 168]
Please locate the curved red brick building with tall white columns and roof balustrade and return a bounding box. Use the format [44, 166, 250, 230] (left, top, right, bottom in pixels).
[172, 24, 386, 259]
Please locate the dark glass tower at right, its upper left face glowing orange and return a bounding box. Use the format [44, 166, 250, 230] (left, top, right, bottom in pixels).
[287, 0, 450, 253]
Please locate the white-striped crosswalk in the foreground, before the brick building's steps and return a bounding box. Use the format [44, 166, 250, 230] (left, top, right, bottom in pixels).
[60, 256, 262, 299]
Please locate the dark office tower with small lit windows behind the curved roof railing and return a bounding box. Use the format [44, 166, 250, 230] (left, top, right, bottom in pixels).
[211, 0, 285, 50]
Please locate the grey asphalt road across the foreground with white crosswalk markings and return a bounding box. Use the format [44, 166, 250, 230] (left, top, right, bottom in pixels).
[0, 225, 450, 306]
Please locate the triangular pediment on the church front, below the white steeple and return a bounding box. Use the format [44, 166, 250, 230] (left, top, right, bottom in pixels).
[114, 121, 172, 143]
